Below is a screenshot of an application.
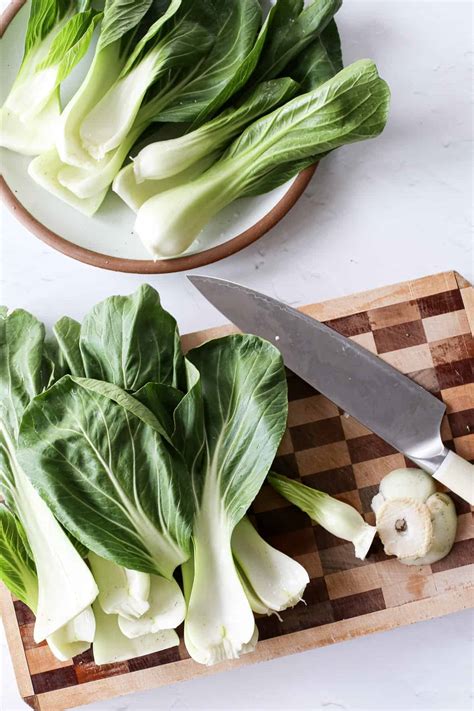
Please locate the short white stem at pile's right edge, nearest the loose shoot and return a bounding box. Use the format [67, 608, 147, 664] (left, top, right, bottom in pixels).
[232, 516, 309, 612]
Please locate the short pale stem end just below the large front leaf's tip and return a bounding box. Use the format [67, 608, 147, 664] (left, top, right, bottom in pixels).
[88, 552, 150, 620]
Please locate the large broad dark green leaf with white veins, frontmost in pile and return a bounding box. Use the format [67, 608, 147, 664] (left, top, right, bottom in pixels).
[20, 376, 192, 579]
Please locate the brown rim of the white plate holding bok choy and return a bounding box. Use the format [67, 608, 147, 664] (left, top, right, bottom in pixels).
[0, 0, 317, 274]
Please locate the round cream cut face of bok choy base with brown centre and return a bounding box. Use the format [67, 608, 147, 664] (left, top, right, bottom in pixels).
[376, 498, 433, 558]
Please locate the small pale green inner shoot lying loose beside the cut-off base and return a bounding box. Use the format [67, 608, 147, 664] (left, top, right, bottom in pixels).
[268, 472, 377, 560]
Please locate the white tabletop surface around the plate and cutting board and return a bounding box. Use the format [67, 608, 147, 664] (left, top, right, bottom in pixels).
[0, 0, 473, 711]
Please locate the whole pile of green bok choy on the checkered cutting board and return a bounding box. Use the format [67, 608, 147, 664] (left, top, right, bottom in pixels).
[0, 285, 384, 665]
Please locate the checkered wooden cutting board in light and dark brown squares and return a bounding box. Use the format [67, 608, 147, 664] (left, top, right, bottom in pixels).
[1, 272, 474, 711]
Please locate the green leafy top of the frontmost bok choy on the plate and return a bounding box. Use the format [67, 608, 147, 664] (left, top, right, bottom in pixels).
[224, 59, 390, 196]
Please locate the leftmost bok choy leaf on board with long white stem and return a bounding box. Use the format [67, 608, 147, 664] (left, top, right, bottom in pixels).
[0, 310, 98, 642]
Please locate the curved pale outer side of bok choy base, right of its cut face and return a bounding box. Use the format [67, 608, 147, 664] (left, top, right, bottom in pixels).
[400, 492, 458, 565]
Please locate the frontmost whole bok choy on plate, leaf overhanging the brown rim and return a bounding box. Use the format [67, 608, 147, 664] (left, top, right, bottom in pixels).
[134, 60, 389, 258]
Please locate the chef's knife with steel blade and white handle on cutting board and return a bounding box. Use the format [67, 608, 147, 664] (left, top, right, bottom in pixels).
[188, 276, 474, 505]
